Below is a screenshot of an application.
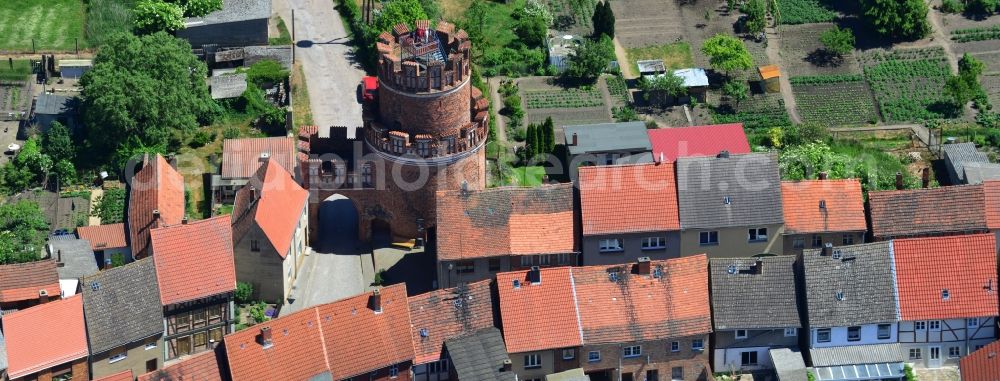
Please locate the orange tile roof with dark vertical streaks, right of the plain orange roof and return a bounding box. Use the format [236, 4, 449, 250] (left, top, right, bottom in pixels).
[572, 254, 712, 345]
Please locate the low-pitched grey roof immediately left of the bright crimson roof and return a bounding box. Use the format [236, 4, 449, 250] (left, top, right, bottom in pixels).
[563, 122, 653, 155]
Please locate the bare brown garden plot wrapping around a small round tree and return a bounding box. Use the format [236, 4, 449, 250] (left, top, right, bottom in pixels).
[779, 23, 861, 77]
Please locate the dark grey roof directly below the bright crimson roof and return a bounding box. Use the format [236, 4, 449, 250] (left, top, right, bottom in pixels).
[676, 153, 784, 229]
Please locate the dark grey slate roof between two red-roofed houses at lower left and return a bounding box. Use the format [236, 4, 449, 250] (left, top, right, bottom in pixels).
[82, 258, 163, 354]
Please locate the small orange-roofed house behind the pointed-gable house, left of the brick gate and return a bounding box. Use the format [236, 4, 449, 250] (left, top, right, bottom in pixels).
[212, 136, 299, 202]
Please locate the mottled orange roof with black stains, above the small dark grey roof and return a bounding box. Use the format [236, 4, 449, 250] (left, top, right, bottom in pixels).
[407, 280, 493, 365]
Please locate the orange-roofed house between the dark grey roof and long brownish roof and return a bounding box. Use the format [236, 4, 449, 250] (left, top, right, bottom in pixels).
[781, 179, 868, 254]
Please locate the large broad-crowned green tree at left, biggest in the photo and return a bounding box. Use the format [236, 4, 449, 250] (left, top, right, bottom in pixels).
[80, 32, 221, 167]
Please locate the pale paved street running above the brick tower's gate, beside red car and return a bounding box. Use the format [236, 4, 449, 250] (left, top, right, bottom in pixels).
[274, 0, 364, 136]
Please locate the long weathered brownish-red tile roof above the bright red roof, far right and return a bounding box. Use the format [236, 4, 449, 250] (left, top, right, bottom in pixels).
[868, 185, 986, 238]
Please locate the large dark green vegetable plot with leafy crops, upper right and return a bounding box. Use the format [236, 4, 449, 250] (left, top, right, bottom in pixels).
[861, 48, 951, 122]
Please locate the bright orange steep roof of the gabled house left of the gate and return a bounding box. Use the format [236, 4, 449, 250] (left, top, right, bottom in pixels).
[233, 160, 309, 258]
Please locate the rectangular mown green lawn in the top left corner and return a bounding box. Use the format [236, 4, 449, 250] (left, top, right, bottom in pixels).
[0, 0, 87, 52]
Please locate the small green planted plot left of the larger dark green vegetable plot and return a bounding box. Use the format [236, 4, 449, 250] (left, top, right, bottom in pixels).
[792, 76, 879, 126]
